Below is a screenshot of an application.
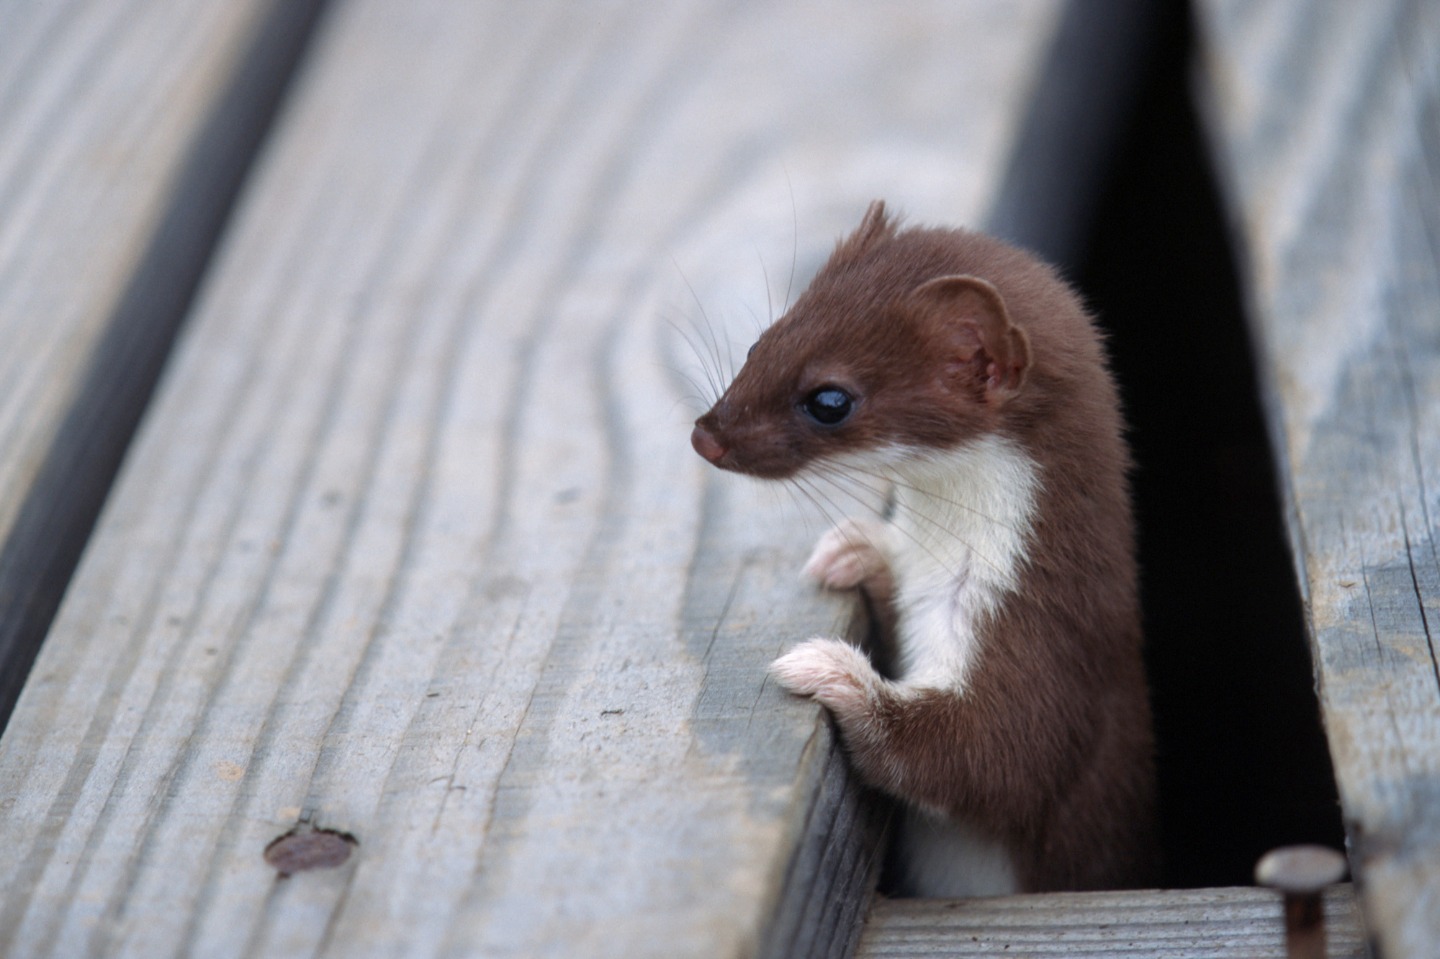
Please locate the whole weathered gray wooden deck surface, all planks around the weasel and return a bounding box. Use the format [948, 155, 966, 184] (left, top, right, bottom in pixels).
[0, 0, 1440, 956]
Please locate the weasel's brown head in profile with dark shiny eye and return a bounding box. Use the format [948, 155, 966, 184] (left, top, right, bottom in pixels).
[690, 200, 1030, 480]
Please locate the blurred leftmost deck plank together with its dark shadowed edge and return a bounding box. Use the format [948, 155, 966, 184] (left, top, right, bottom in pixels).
[0, 0, 325, 726]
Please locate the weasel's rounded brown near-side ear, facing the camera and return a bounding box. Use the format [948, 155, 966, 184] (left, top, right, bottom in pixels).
[910, 275, 1030, 405]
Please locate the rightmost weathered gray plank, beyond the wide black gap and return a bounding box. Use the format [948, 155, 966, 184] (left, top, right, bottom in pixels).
[1198, 0, 1440, 956]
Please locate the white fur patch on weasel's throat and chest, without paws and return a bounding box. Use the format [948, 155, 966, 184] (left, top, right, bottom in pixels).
[888, 435, 1040, 691]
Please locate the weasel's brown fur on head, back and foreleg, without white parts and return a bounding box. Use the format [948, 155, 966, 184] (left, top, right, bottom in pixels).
[694, 202, 1155, 891]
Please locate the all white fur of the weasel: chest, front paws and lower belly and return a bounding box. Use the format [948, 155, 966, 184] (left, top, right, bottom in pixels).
[770, 436, 1040, 896]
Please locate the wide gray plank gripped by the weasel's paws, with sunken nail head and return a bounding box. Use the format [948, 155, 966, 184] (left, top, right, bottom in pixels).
[0, 0, 1060, 956]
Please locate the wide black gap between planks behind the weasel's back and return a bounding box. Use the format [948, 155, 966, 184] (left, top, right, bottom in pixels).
[1071, 3, 1344, 887]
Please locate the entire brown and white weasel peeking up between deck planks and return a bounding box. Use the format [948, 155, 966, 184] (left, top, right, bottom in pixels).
[691, 202, 1155, 897]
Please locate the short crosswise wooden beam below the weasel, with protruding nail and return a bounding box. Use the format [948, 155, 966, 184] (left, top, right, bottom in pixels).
[857, 886, 1367, 959]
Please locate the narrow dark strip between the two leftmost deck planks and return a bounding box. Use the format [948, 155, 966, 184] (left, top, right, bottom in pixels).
[0, 0, 325, 731]
